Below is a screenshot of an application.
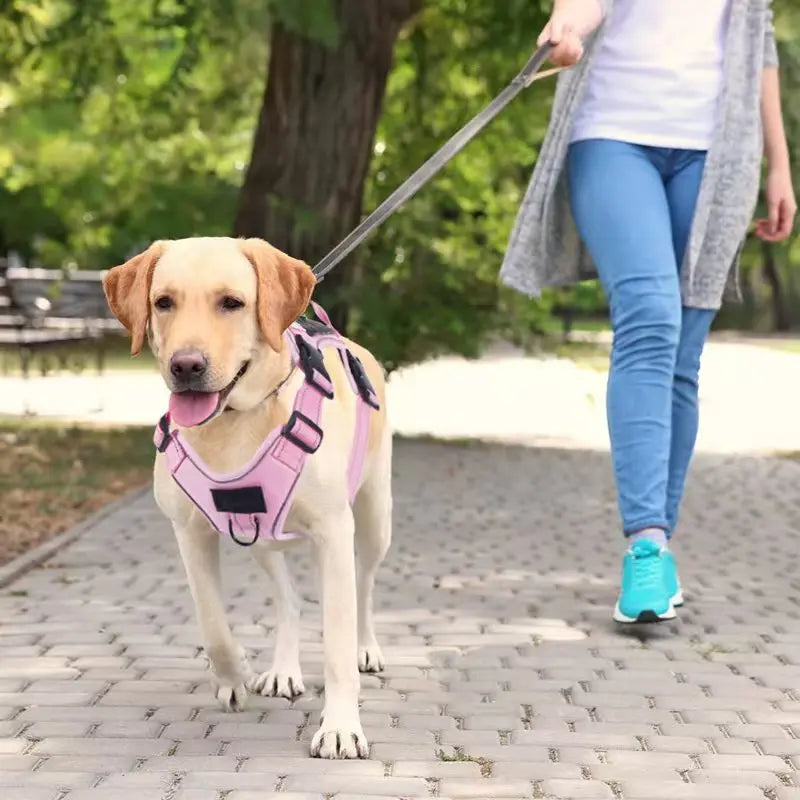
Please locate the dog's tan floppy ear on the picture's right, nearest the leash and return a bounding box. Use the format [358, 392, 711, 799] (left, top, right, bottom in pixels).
[240, 239, 317, 352]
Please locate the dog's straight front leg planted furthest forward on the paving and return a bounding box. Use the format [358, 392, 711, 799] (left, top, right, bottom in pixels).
[311, 506, 369, 758]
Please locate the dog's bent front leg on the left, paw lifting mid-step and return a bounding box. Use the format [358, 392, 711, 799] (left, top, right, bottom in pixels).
[174, 521, 253, 711]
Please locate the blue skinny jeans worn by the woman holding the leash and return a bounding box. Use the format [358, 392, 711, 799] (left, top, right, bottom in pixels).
[567, 139, 715, 536]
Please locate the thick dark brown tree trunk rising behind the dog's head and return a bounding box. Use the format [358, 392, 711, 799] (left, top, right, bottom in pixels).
[234, 0, 421, 325]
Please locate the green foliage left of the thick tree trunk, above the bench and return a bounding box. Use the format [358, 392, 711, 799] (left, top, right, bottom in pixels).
[0, 0, 268, 267]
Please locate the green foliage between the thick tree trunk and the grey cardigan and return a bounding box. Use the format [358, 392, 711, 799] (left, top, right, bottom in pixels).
[341, 0, 552, 367]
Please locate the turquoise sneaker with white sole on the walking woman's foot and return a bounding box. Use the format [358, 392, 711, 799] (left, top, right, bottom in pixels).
[614, 539, 677, 623]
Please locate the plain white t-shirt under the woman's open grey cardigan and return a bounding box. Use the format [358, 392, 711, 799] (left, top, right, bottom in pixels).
[571, 0, 731, 150]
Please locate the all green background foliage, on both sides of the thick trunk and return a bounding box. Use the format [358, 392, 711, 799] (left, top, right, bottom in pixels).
[0, 0, 800, 367]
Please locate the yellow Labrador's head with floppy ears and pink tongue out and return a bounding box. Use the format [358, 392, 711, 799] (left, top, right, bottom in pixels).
[103, 237, 316, 427]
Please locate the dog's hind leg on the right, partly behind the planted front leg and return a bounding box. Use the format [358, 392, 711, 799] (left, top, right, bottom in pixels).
[353, 431, 392, 672]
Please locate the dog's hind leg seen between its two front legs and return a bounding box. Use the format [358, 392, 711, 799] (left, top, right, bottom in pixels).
[248, 546, 305, 700]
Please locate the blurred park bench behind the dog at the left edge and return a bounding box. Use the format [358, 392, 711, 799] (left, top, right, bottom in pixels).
[0, 262, 121, 378]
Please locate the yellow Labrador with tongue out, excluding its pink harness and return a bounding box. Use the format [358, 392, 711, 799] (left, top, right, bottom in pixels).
[104, 238, 392, 758]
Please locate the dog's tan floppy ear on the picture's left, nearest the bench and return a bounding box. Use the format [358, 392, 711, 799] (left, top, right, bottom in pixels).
[103, 242, 164, 356]
